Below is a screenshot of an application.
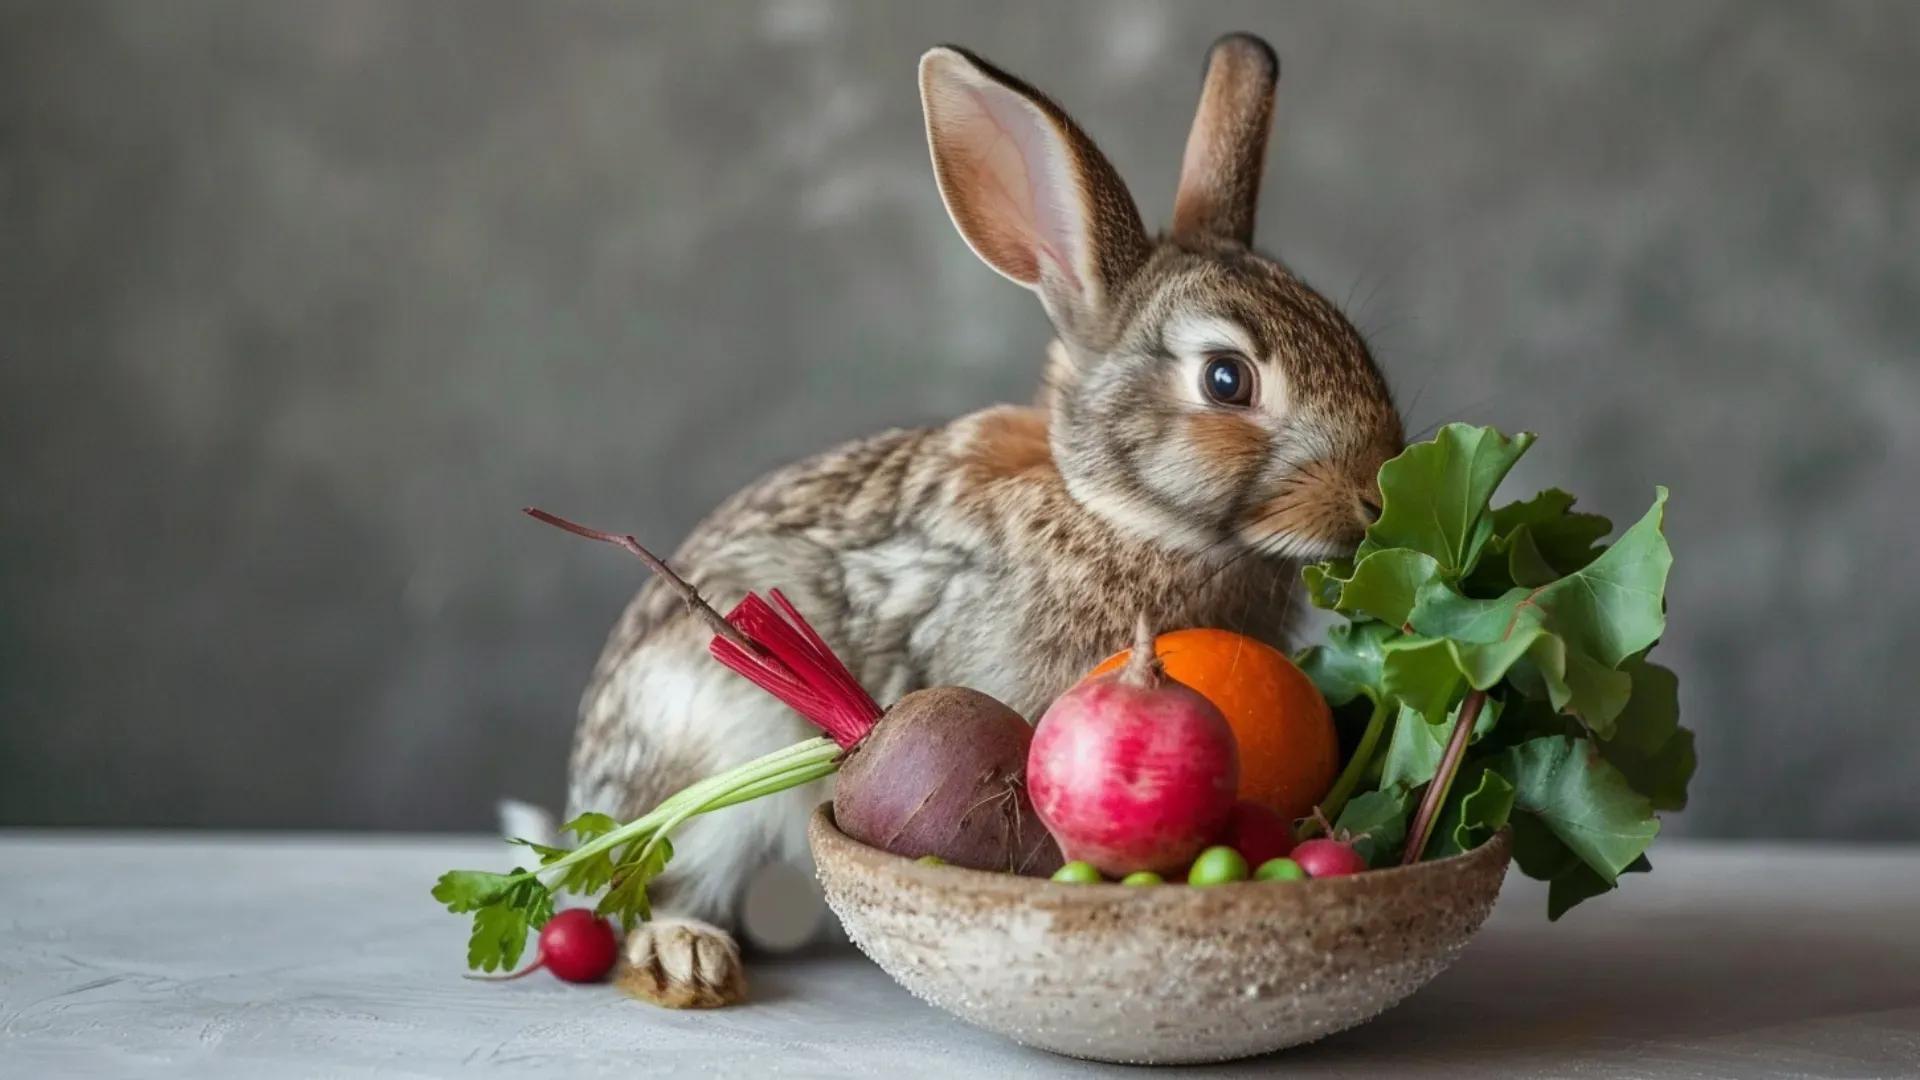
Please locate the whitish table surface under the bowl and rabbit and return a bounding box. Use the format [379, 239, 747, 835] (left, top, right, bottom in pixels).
[0, 832, 1920, 1080]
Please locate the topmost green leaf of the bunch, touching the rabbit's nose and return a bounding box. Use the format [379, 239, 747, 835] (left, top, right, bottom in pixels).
[1356, 423, 1534, 580]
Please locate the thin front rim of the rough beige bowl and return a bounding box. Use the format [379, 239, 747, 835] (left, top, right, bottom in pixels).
[806, 799, 1513, 903]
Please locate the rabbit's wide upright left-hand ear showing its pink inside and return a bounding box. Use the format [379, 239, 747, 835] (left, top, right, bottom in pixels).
[920, 46, 1148, 334]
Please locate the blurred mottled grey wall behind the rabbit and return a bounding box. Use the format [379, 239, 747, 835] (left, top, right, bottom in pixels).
[0, 0, 1920, 840]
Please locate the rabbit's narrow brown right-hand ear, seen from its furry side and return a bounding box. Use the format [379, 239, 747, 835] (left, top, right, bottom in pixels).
[1173, 35, 1281, 244]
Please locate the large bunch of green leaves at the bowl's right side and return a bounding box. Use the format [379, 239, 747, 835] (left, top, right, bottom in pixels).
[1300, 425, 1693, 919]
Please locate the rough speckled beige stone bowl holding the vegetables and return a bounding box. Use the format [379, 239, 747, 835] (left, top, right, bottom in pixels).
[810, 805, 1509, 1065]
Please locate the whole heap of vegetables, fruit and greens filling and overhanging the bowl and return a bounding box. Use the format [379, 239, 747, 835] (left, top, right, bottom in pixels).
[434, 425, 1693, 978]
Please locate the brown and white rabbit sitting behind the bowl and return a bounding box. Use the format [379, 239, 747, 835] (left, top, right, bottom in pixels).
[570, 35, 1402, 1005]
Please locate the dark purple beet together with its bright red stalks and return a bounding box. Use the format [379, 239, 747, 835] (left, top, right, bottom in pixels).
[526, 509, 1062, 874]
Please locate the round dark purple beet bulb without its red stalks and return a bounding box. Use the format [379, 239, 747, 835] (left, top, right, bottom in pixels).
[833, 686, 1062, 876]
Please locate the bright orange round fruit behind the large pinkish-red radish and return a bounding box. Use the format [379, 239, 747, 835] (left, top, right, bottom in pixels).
[1087, 630, 1340, 821]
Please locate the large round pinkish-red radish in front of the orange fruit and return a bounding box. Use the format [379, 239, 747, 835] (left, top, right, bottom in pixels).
[1027, 617, 1240, 876]
